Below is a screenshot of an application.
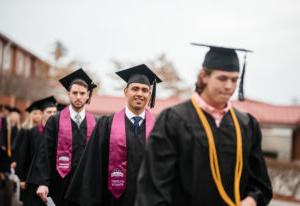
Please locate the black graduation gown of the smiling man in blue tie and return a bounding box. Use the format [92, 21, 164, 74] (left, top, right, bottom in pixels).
[66, 116, 146, 206]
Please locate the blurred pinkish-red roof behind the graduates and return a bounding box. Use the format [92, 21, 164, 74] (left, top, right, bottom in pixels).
[87, 95, 300, 126]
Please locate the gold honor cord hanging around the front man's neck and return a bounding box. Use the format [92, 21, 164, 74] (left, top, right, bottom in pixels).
[192, 97, 243, 206]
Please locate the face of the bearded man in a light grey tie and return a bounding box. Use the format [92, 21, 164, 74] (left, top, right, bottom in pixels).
[68, 84, 89, 110]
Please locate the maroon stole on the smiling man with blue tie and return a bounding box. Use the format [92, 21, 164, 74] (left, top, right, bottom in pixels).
[108, 109, 155, 199]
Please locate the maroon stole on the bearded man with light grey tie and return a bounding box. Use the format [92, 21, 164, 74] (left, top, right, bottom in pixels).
[56, 107, 96, 178]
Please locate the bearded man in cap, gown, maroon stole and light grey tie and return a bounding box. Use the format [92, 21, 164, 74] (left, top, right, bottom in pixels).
[32, 69, 96, 206]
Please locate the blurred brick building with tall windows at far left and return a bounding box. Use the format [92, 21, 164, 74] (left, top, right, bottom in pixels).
[0, 33, 51, 110]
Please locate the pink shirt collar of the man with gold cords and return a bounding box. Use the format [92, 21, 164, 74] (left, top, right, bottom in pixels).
[193, 92, 231, 126]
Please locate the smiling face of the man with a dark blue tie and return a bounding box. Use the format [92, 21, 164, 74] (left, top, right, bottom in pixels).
[124, 83, 151, 112]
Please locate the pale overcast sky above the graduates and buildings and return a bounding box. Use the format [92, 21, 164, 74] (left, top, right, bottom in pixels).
[0, 0, 300, 104]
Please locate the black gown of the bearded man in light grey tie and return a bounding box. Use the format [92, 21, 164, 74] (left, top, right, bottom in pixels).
[28, 113, 95, 206]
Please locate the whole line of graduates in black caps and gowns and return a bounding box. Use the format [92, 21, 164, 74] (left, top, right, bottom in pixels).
[0, 44, 272, 206]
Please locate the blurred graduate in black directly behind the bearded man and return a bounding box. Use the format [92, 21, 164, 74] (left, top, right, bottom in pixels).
[15, 96, 57, 206]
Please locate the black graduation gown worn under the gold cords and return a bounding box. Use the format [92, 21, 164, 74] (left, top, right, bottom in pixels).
[135, 101, 272, 206]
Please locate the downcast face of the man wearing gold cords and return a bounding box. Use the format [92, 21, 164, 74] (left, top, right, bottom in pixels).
[202, 70, 239, 107]
